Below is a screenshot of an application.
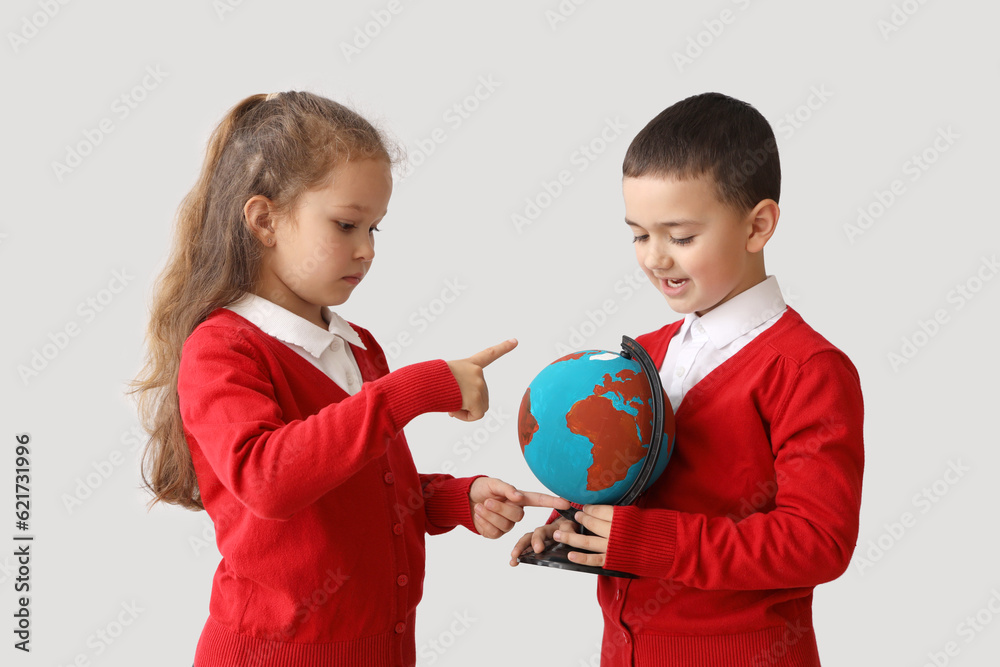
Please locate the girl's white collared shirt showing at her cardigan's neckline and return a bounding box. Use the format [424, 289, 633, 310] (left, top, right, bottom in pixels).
[226, 293, 366, 394]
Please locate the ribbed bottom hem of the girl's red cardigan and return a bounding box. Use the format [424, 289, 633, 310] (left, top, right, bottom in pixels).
[194, 616, 414, 667]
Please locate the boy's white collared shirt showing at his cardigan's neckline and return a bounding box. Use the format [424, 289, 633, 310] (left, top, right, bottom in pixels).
[660, 276, 787, 412]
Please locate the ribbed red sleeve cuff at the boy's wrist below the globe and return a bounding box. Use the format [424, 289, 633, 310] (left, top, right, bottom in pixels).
[604, 505, 677, 579]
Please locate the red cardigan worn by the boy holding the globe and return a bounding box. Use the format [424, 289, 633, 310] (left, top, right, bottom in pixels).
[598, 308, 864, 667]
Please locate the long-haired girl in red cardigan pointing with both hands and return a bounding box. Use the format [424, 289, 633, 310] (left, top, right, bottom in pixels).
[134, 92, 569, 667]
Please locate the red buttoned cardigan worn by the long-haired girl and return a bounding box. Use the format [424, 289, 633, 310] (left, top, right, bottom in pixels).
[177, 308, 475, 667]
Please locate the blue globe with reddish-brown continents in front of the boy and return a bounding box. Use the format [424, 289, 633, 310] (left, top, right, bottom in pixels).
[518, 350, 674, 505]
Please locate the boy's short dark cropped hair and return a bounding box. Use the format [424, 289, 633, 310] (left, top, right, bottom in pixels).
[622, 93, 781, 213]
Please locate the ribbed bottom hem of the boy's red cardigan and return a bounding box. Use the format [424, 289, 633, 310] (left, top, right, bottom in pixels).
[616, 627, 820, 667]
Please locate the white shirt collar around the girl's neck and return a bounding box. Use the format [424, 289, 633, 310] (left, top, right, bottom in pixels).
[226, 292, 367, 359]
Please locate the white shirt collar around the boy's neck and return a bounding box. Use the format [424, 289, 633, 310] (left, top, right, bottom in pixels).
[684, 276, 785, 349]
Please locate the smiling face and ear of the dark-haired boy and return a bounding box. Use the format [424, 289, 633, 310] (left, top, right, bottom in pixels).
[622, 176, 778, 316]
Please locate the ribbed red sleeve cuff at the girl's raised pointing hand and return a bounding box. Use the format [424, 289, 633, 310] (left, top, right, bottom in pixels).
[376, 359, 462, 432]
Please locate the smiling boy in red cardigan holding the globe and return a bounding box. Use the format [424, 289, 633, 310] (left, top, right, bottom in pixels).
[511, 93, 864, 667]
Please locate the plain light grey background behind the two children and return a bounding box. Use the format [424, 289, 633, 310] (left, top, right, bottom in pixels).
[0, 0, 1000, 667]
